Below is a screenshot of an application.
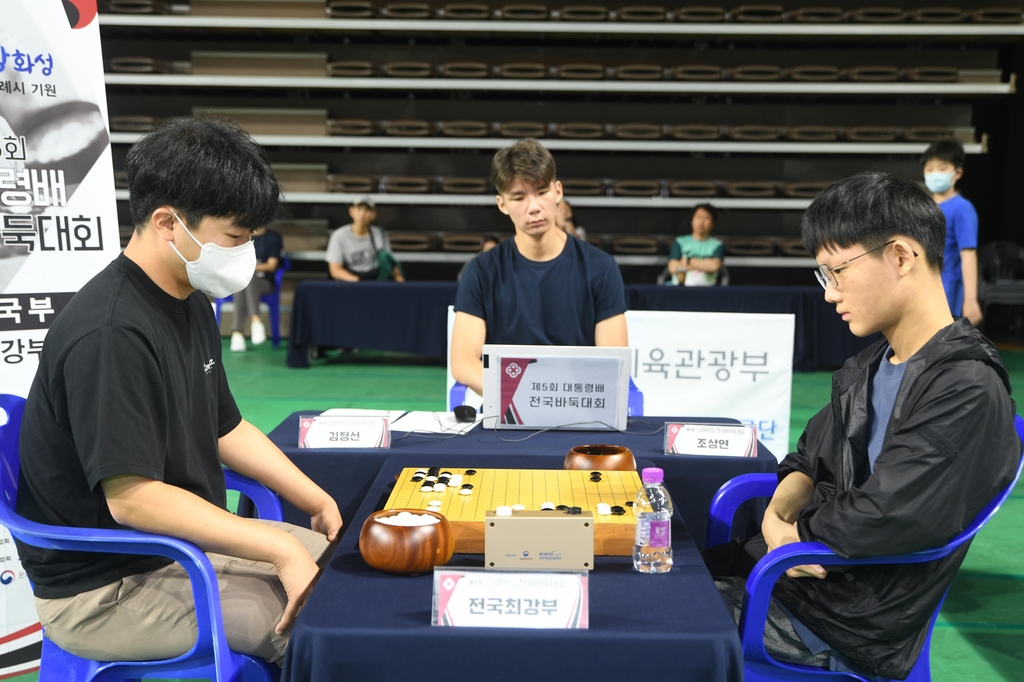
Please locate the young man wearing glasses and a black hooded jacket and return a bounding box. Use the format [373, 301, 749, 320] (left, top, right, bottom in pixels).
[705, 173, 1021, 679]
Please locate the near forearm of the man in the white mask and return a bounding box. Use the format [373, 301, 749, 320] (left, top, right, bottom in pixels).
[102, 476, 304, 565]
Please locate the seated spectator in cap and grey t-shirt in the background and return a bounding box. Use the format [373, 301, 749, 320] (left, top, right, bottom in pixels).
[327, 197, 406, 282]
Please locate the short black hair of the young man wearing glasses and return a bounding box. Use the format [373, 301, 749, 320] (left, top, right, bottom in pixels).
[800, 172, 946, 270]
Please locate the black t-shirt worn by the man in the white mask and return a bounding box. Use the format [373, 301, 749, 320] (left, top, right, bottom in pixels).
[17, 255, 242, 599]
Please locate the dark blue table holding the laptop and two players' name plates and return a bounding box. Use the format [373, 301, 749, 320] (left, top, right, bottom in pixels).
[269, 411, 777, 548]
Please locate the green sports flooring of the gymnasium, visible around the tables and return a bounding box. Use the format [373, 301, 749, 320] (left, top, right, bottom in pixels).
[10, 340, 1024, 682]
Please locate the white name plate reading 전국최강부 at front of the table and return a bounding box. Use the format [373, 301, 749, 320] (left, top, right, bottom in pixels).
[431, 567, 590, 630]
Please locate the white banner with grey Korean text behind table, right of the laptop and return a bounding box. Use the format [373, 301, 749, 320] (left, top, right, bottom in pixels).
[626, 310, 796, 460]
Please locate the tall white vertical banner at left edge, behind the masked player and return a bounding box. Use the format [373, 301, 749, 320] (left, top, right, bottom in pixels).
[0, 0, 120, 667]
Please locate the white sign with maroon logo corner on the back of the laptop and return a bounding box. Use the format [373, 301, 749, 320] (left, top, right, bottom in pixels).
[492, 356, 622, 429]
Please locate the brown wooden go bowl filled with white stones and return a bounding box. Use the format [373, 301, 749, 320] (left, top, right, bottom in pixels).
[359, 509, 455, 573]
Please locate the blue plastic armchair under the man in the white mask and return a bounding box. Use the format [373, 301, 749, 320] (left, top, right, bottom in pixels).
[0, 394, 283, 682]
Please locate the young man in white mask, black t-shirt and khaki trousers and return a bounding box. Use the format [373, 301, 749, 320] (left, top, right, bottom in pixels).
[17, 118, 342, 664]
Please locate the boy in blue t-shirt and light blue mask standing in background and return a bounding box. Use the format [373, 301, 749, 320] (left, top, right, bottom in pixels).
[921, 140, 981, 325]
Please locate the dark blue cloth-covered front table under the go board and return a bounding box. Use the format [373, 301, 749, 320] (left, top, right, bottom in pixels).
[282, 456, 742, 682]
